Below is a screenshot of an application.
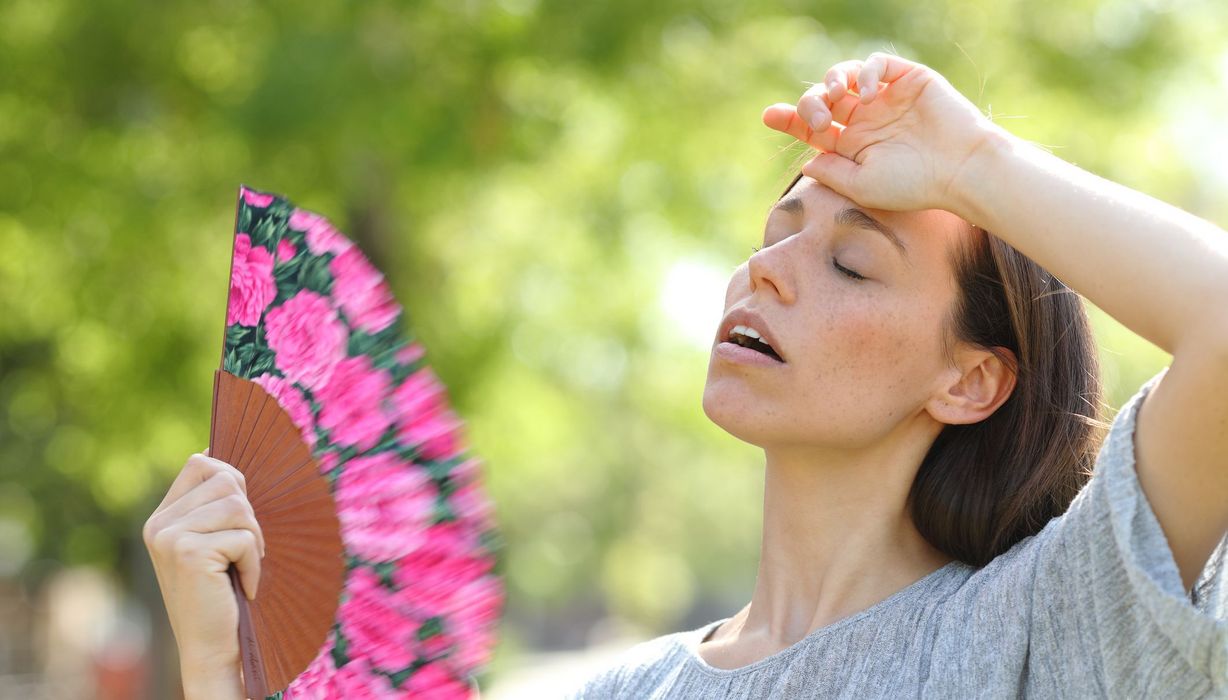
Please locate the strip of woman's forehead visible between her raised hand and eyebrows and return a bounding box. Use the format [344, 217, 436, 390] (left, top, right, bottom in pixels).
[776, 176, 973, 269]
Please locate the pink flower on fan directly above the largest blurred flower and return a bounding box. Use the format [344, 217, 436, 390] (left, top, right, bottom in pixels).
[316, 355, 392, 449]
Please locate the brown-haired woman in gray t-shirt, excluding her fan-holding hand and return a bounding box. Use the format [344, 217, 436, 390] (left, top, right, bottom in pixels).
[573, 54, 1228, 698]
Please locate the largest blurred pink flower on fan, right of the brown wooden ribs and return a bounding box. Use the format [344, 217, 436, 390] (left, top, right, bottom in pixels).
[335, 452, 437, 562]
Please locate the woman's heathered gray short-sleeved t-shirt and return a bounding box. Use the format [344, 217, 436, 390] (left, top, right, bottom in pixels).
[569, 370, 1228, 700]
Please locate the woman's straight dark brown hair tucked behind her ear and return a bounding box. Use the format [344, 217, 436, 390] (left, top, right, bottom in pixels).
[909, 228, 1106, 566]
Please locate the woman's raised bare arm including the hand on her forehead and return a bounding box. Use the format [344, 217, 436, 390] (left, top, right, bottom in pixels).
[764, 54, 1228, 589]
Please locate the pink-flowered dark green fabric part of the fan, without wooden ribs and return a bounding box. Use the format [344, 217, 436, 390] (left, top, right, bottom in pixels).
[223, 188, 502, 700]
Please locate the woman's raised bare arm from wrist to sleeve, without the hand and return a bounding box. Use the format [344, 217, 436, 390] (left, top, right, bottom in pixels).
[957, 129, 1228, 591]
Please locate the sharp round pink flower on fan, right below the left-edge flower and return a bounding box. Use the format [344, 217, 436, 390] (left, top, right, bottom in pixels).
[264, 290, 348, 389]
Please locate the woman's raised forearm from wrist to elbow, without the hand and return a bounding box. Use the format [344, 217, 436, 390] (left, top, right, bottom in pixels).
[953, 129, 1228, 355]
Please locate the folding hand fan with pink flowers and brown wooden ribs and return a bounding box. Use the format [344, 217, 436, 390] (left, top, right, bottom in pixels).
[209, 188, 503, 700]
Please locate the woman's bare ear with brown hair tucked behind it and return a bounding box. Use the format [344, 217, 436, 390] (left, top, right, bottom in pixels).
[926, 346, 1019, 425]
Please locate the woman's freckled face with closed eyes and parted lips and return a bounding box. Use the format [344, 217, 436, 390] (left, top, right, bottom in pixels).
[704, 177, 973, 449]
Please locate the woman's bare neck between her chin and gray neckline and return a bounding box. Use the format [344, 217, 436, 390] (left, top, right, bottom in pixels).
[731, 424, 950, 648]
